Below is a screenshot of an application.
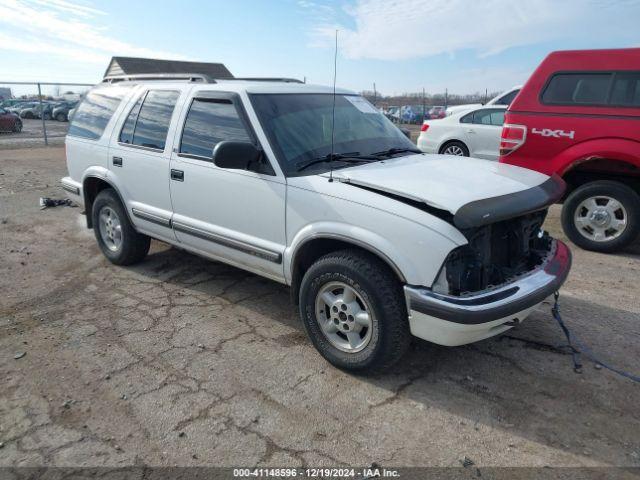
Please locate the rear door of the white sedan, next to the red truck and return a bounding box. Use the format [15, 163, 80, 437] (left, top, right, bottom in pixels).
[467, 108, 505, 160]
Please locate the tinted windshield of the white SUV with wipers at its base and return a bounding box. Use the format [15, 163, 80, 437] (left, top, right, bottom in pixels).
[251, 93, 416, 176]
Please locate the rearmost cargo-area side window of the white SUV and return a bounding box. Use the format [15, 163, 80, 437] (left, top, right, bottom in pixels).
[68, 86, 131, 140]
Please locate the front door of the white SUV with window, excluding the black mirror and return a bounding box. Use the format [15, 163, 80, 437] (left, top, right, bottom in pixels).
[171, 92, 286, 281]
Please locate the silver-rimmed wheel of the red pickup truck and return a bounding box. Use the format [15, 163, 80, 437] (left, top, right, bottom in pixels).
[562, 180, 640, 253]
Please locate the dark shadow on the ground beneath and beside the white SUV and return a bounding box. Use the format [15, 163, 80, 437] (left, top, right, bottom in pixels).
[131, 244, 640, 465]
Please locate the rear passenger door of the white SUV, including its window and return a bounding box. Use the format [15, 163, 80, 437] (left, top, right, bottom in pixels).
[109, 86, 184, 240]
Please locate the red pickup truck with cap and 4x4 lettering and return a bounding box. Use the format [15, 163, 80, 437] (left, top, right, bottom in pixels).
[500, 48, 640, 252]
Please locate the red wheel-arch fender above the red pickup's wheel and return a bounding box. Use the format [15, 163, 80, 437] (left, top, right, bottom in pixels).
[552, 138, 640, 176]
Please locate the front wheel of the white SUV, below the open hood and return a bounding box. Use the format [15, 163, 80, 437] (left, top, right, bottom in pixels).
[300, 250, 411, 373]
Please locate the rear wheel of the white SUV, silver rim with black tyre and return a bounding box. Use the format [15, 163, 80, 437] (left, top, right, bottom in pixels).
[92, 188, 151, 265]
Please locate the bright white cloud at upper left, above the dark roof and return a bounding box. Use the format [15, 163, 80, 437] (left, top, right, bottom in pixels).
[0, 0, 190, 67]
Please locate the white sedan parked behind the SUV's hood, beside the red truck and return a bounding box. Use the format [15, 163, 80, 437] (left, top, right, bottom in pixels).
[417, 105, 507, 160]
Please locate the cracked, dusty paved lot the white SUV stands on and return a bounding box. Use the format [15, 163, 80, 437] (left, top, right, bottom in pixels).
[0, 148, 640, 467]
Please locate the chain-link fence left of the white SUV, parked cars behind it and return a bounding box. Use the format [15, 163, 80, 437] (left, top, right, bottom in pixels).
[0, 80, 93, 149]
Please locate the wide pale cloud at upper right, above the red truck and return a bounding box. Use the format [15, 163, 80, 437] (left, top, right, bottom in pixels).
[311, 0, 640, 60]
